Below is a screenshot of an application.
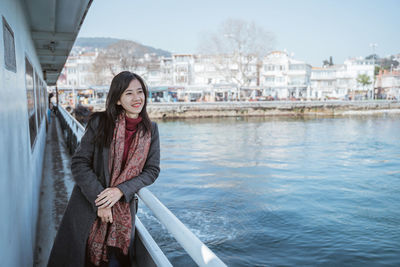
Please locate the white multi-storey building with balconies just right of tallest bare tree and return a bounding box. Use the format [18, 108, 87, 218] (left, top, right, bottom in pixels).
[260, 51, 311, 99]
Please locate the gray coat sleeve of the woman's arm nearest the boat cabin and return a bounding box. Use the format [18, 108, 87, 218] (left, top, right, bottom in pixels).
[71, 118, 104, 212]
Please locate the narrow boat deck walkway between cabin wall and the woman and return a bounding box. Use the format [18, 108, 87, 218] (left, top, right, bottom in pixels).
[34, 114, 74, 266]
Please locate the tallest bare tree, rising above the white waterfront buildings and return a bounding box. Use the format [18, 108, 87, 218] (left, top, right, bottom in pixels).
[200, 19, 274, 90]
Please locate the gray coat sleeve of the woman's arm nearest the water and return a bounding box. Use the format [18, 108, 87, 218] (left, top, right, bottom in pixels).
[117, 123, 160, 202]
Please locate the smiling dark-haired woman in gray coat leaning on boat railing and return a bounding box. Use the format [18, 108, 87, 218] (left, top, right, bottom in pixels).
[48, 71, 160, 267]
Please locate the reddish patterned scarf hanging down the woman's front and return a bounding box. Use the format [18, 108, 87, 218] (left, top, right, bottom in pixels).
[88, 114, 151, 266]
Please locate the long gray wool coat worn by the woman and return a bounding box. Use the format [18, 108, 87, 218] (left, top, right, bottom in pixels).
[47, 120, 160, 267]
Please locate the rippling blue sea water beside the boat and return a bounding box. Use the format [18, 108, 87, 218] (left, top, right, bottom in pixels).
[139, 115, 400, 266]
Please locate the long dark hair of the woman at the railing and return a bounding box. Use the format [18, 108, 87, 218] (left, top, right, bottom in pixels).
[88, 71, 151, 147]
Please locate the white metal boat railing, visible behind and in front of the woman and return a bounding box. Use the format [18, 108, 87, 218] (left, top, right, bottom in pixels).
[58, 106, 226, 267]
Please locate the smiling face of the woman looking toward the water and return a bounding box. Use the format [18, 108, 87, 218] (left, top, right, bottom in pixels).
[117, 79, 145, 119]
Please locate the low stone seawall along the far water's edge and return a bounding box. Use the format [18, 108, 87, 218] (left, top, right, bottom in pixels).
[147, 100, 400, 119]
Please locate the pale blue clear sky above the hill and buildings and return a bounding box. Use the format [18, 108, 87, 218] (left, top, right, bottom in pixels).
[78, 0, 400, 66]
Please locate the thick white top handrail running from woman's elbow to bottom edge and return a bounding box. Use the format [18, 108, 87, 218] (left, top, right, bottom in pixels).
[138, 187, 226, 266]
